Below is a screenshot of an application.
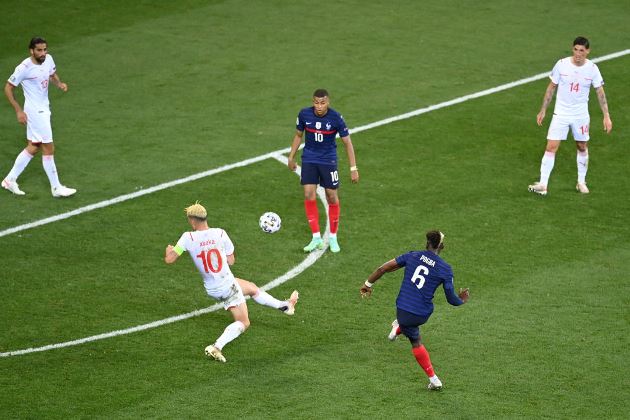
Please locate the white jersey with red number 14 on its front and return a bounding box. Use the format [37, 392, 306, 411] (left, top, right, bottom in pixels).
[549, 57, 604, 118]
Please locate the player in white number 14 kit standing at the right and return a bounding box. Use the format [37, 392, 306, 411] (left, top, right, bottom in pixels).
[528, 36, 612, 195]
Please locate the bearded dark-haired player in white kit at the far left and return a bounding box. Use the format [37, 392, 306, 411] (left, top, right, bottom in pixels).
[2, 38, 77, 197]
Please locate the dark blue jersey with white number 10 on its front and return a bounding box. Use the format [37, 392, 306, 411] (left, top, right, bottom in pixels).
[295, 107, 349, 165]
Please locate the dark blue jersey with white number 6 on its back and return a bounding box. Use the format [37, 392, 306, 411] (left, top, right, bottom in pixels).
[396, 251, 455, 318]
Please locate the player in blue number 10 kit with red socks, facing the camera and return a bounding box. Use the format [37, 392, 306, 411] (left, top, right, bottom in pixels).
[288, 89, 359, 252]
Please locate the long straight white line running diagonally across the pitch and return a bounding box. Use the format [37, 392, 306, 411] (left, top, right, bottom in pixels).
[0, 49, 630, 237]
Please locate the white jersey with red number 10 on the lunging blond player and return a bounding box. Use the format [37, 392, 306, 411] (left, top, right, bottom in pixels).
[177, 228, 235, 294]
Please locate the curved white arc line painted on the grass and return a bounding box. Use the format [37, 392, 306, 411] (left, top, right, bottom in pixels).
[0, 156, 329, 357]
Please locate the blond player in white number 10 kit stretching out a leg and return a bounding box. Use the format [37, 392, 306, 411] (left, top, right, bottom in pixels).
[164, 202, 299, 363]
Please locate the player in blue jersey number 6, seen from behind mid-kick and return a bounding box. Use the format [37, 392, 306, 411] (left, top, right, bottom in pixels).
[361, 230, 469, 390]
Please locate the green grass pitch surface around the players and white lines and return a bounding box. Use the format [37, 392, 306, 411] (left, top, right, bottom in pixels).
[0, 0, 630, 419]
